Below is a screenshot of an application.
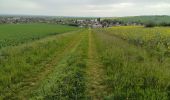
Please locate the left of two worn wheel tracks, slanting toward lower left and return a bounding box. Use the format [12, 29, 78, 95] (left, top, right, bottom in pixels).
[11, 31, 81, 100]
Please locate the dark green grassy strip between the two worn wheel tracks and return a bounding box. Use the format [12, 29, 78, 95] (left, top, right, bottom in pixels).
[30, 31, 88, 100]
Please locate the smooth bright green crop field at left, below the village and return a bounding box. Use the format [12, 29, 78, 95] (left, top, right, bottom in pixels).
[0, 24, 77, 49]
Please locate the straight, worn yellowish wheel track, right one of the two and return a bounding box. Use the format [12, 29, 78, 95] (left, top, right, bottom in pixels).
[87, 29, 106, 100]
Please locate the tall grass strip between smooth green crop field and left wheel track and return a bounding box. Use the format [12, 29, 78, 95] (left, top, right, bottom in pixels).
[0, 32, 80, 99]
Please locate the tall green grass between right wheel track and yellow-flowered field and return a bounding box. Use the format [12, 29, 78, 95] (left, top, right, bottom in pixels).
[93, 30, 170, 100]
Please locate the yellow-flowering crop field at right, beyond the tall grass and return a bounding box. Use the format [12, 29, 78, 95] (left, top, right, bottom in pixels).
[106, 26, 170, 63]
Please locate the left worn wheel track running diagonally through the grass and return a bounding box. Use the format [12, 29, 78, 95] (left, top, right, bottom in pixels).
[19, 29, 84, 99]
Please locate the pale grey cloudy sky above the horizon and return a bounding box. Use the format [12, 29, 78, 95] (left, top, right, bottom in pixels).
[0, 0, 170, 17]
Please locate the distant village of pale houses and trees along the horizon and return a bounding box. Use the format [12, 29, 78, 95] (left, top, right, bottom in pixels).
[0, 16, 141, 28]
